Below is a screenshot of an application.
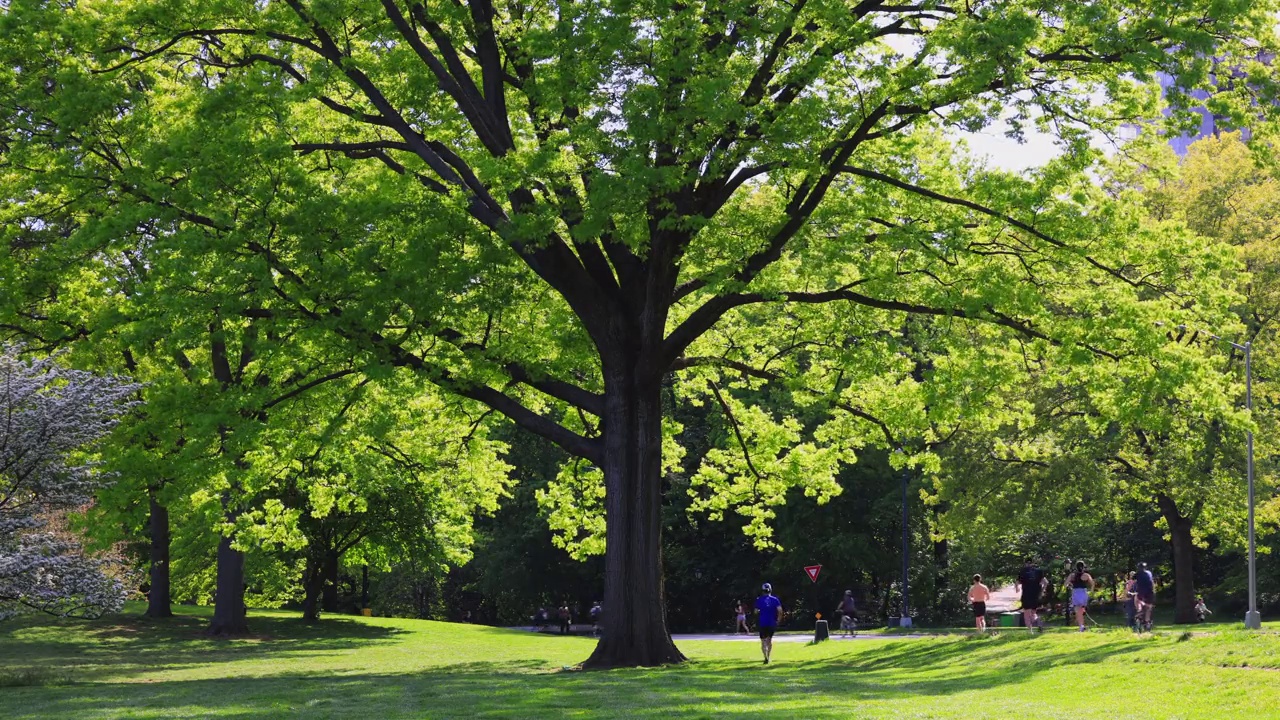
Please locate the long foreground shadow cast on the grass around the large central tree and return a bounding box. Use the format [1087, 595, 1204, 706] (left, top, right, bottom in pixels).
[0, 630, 1162, 720]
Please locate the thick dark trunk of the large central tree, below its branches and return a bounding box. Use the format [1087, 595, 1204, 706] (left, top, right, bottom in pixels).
[585, 368, 685, 667]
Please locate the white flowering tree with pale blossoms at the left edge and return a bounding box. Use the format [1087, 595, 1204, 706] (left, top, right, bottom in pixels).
[0, 347, 138, 619]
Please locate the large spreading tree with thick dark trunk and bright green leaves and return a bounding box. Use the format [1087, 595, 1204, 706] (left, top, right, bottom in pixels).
[3, 0, 1271, 666]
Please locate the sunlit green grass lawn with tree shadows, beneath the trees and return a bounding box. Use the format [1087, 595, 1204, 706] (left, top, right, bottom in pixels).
[0, 607, 1280, 720]
